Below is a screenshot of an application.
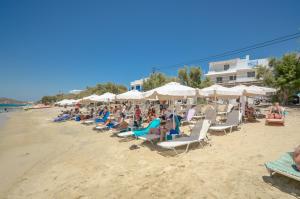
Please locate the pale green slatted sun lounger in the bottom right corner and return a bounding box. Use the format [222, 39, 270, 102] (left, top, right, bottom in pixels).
[265, 152, 300, 181]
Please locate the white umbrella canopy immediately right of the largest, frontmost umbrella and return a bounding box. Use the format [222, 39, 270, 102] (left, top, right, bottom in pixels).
[199, 84, 242, 98]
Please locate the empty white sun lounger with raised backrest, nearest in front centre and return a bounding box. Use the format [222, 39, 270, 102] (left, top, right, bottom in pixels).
[157, 119, 210, 154]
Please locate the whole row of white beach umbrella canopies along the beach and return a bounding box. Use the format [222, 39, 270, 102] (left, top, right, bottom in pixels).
[57, 82, 276, 105]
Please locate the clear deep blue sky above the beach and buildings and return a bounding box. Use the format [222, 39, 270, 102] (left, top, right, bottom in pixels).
[0, 0, 300, 100]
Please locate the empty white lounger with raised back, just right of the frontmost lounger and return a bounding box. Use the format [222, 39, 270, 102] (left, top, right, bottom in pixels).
[209, 110, 240, 134]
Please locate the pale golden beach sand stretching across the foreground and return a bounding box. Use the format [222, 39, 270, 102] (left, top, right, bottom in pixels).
[0, 108, 300, 199]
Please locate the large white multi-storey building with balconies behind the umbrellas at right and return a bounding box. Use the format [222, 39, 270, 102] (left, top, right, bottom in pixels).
[205, 55, 269, 86]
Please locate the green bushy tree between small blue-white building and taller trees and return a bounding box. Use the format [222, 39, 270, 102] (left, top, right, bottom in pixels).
[143, 73, 178, 91]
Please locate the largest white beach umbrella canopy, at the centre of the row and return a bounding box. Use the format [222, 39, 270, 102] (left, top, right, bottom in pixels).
[143, 82, 197, 100]
